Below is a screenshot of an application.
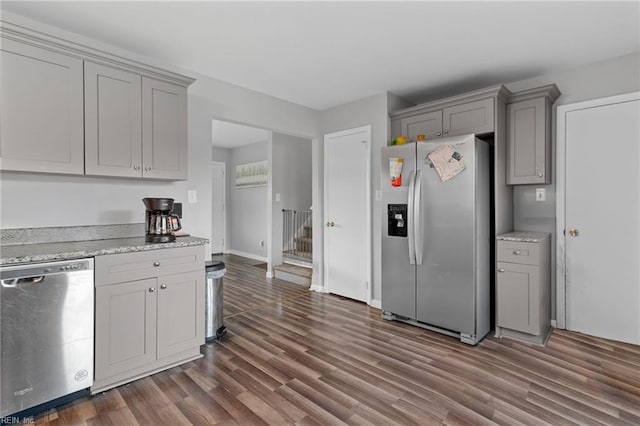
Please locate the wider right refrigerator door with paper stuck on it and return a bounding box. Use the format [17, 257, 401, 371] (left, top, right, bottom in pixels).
[416, 135, 476, 335]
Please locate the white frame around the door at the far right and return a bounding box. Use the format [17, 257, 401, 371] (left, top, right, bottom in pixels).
[556, 92, 640, 329]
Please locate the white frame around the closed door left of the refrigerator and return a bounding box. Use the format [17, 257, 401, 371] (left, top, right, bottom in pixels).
[319, 124, 373, 305]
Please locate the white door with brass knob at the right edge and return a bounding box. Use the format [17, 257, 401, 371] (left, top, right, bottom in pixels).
[558, 94, 640, 344]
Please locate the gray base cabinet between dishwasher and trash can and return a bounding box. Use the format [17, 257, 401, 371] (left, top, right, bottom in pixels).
[91, 246, 205, 393]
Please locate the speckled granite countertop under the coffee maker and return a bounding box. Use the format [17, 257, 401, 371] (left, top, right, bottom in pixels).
[0, 236, 208, 265]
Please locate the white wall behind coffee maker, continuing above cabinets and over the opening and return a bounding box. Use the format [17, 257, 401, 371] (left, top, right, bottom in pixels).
[0, 13, 319, 260]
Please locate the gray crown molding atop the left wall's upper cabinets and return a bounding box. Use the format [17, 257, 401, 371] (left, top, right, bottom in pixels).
[0, 19, 195, 87]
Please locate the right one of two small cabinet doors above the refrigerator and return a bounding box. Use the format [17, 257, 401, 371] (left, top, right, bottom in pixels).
[442, 98, 494, 137]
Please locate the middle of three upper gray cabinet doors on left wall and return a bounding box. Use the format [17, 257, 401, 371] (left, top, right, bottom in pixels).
[84, 62, 142, 177]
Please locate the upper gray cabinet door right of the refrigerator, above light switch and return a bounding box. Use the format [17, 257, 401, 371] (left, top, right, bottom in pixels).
[507, 98, 551, 185]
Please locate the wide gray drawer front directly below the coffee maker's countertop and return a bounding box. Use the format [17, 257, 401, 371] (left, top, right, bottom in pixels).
[95, 246, 204, 286]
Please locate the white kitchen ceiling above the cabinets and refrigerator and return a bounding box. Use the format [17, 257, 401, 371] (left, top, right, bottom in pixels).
[2, 1, 640, 110]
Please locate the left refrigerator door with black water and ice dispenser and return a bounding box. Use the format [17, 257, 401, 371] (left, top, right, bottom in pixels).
[380, 143, 416, 318]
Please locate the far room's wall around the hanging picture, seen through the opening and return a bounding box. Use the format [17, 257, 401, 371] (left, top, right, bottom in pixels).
[227, 141, 270, 258]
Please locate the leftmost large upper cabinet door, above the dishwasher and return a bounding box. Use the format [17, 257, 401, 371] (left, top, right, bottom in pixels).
[0, 38, 84, 174]
